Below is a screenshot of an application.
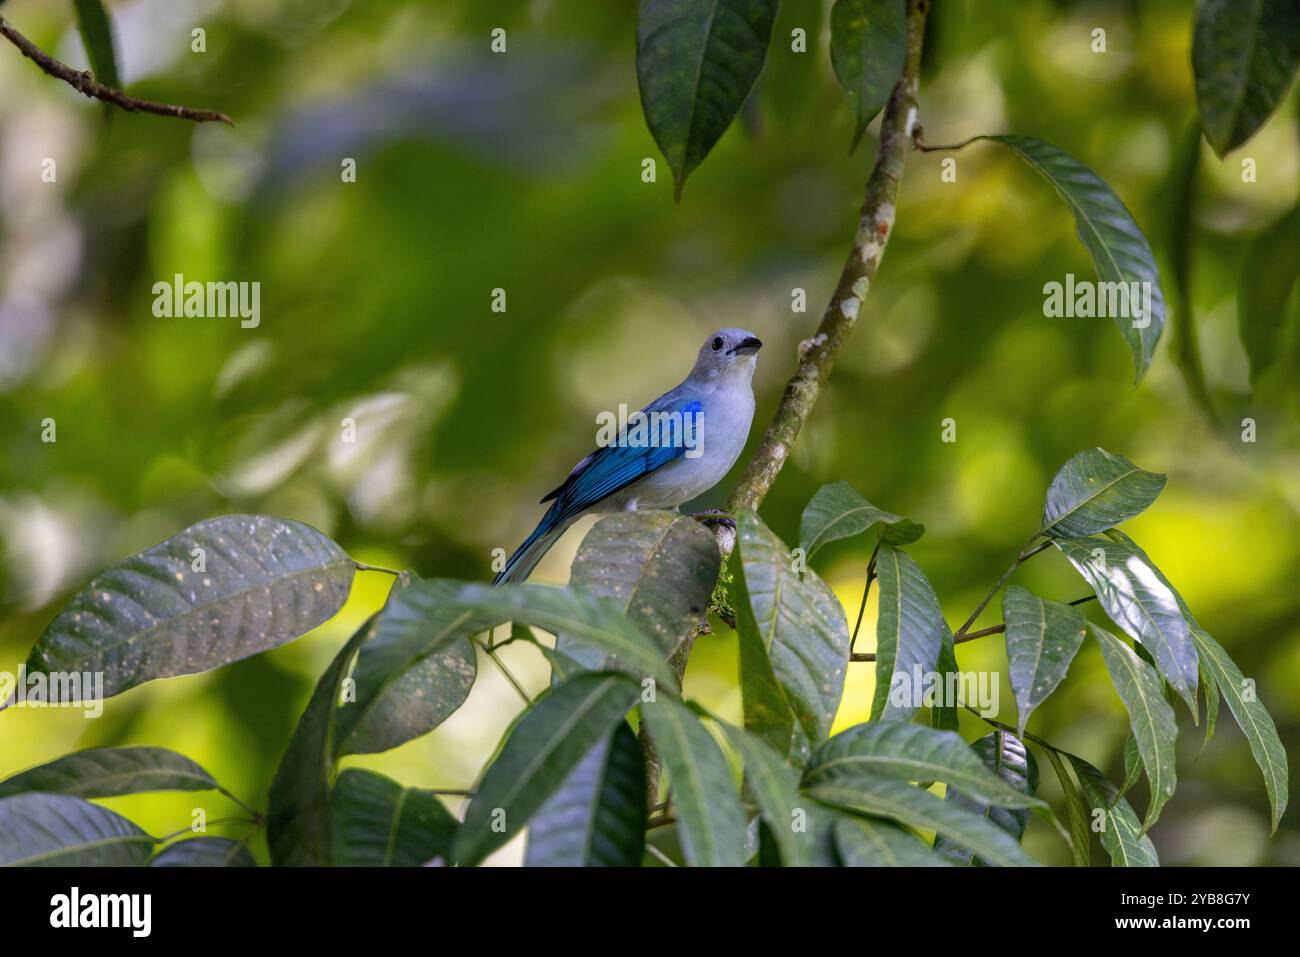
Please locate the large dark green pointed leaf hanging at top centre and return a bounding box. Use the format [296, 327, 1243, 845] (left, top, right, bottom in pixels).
[637, 0, 777, 196]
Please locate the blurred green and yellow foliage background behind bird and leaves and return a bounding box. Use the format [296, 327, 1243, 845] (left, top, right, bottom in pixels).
[0, 0, 1300, 865]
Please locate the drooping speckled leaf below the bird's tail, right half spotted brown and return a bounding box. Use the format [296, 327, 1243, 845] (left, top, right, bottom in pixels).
[334, 572, 480, 757]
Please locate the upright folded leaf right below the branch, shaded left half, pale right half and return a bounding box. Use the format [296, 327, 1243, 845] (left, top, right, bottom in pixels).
[736, 510, 849, 757]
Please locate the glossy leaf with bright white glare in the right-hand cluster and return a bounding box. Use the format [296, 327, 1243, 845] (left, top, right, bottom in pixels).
[1054, 538, 1197, 715]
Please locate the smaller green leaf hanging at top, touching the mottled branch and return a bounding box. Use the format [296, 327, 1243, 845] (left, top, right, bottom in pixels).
[831, 0, 907, 152]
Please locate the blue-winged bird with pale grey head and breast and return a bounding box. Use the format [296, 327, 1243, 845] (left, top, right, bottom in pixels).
[493, 329, 763, 585]
